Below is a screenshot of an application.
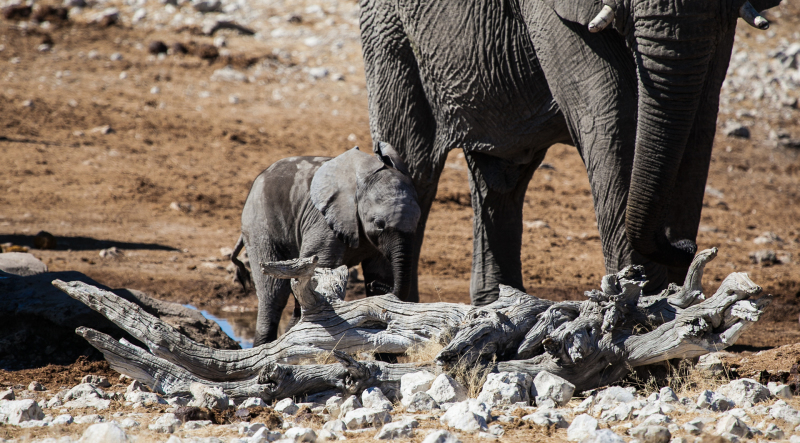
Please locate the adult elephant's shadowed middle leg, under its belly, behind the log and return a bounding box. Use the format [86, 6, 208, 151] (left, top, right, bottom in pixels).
[466, 149, 546, 306]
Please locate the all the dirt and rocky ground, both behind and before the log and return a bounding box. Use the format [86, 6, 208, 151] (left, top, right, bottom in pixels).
[0, 0, 800, 442]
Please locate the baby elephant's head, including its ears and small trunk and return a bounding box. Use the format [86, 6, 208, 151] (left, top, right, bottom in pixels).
[311, 142, 421, 299]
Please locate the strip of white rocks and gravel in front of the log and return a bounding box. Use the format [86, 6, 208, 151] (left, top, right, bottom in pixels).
[0, 360, 800, 443]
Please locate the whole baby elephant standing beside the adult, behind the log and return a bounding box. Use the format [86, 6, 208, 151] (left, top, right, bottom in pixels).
[231, 143, 420, 346]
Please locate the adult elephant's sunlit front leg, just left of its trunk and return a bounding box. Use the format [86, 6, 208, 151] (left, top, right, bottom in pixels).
[523, 6, 667, 292]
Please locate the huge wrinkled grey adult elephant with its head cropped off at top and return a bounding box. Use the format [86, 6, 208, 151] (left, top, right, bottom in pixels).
[361, 0, 780, 305]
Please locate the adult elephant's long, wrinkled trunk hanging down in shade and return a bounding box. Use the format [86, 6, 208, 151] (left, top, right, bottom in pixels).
[626, 32, 713, 267]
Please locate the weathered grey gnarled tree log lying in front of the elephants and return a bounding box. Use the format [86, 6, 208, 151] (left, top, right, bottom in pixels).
[53, 249, 769, 400]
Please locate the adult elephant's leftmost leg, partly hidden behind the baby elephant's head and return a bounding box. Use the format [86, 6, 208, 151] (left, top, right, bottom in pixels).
[361, 0, 448, 301]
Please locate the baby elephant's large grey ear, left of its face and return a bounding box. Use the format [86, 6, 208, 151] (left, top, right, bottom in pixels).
[311, 147, 383, 248]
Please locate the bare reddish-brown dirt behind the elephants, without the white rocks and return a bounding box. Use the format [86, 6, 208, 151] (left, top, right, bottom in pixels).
[0, 0, 800, 384]
